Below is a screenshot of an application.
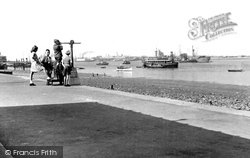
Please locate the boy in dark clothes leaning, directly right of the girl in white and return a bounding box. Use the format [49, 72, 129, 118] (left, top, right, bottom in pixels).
[41, 49, 53, 85]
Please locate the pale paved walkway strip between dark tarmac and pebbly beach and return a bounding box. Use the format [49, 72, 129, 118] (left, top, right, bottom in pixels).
[0, 74, 250, 139]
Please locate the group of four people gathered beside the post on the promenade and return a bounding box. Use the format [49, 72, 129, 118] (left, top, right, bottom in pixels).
[30, 39, 72, 86]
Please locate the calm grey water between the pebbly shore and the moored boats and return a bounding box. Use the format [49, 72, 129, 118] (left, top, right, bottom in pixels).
[75, 58, 250, 86]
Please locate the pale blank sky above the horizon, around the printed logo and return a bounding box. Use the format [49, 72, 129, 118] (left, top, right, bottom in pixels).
[0, 0, 250, 60]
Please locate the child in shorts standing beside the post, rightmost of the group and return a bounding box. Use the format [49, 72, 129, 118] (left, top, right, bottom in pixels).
[63, 50, 71, 86]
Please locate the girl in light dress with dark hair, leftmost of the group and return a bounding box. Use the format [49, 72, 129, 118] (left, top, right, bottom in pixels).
[30, 45, 42, 86]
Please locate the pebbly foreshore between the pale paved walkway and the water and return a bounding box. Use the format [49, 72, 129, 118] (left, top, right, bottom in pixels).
[13, 70, 250, 111]
